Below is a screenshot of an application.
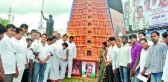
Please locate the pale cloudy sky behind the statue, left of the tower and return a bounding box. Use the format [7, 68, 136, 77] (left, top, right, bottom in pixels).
[0, 0, 73, 32]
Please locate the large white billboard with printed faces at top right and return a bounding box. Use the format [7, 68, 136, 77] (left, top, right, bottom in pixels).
[130, 0, 168, 30]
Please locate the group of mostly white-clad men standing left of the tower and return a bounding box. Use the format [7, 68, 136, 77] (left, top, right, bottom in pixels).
[0, 24, 76, 82]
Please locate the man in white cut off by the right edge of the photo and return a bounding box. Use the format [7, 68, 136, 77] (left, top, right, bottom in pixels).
[162, 30, 168, 82]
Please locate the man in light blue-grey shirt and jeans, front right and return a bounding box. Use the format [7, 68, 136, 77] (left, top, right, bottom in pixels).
[141, 31, 167, 82]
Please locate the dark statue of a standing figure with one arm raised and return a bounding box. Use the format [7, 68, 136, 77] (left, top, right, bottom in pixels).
[41, 11, 54, 37]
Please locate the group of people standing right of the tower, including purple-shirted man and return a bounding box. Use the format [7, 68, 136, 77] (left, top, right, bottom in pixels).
[98, 31, 168, 82]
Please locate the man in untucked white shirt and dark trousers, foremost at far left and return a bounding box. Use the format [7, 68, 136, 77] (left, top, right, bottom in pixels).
[0, 24, 18, 82]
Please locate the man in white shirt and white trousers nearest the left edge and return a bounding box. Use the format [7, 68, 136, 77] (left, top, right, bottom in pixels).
[11, 28, 25, 82]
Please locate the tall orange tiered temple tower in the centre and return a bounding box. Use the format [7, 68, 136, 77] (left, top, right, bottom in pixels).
[67, 0, 113, 61]
